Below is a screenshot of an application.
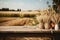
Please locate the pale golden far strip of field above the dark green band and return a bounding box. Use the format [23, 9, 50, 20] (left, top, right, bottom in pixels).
[0, 11, 39, 15]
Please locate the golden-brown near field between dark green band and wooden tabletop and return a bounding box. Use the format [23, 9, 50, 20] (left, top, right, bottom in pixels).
[0, 17, 34, 26]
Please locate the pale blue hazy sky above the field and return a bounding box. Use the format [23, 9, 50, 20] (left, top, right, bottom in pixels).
[0, 0, 52, 10]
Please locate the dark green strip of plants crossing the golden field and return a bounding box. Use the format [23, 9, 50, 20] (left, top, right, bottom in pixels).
[0, 13, 36, 18]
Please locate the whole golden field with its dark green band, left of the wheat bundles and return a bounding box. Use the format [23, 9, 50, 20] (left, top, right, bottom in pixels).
[0, 11, 39, 26]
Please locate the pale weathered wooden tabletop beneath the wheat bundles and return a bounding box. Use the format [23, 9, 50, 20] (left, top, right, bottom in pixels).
[0, 26, 60, 33]
